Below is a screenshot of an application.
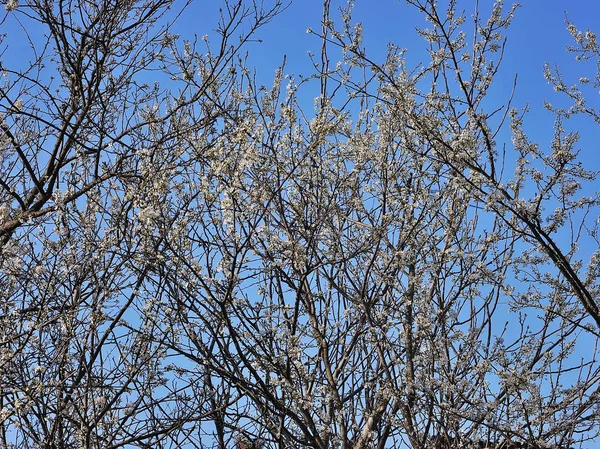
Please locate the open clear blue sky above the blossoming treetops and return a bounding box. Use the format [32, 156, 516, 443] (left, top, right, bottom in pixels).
[0, 0, 600, 444]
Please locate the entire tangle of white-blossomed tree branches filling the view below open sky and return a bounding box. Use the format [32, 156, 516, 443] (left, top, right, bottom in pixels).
[0, 0, 600, 449]
